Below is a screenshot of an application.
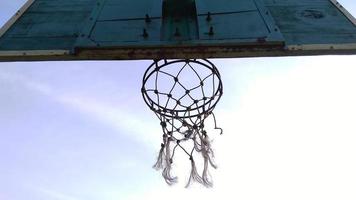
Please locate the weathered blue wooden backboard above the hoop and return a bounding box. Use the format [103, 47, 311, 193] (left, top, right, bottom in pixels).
[0, 0, 356, 61]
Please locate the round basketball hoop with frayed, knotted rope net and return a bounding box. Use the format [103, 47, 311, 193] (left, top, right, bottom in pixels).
[142, 59, 223, 187]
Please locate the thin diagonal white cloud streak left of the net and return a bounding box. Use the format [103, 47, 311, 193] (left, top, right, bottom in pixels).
[0, 72, 159, 147]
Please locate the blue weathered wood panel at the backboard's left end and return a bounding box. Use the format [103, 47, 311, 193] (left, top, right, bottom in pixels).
[0, 0, 95, 50]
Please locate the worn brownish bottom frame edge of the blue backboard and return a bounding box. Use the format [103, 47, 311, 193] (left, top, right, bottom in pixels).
[0, 43, 356, 62]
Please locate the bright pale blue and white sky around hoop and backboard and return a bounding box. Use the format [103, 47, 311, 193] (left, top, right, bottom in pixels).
[0, 0, 356, 200]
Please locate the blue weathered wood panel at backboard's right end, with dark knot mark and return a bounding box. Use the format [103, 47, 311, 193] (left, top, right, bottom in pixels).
[264, 0, 356, 45]
